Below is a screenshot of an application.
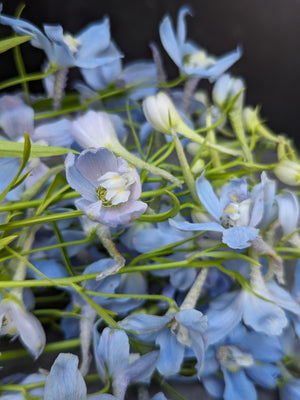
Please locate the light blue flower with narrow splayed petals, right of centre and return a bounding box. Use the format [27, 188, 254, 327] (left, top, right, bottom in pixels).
[170, 174, 274, 249]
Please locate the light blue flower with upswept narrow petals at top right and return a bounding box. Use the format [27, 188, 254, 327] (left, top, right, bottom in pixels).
[159, 7, 242, 82]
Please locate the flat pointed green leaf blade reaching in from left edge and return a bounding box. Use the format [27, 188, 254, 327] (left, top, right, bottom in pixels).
[0, 140, 78, 158]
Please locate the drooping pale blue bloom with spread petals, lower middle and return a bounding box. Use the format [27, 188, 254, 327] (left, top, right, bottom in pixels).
[119, 309, 207, 377]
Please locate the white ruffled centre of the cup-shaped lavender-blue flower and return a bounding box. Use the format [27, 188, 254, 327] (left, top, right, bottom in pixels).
[96, 172, 135, 207]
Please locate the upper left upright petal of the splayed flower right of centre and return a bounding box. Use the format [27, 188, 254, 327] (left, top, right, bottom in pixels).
[196, 174, 223, 221]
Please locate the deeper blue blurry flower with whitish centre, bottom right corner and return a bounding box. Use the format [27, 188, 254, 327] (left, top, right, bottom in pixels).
[200, 325, 284, 400]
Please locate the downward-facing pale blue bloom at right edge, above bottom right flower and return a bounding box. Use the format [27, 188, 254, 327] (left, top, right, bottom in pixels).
[206, 268, 300, 344]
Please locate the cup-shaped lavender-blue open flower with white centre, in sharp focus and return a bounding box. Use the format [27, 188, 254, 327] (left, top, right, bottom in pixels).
[65, 147, 147, 227]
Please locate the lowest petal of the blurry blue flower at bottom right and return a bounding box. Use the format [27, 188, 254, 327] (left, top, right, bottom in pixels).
[222, 368, 257, 400]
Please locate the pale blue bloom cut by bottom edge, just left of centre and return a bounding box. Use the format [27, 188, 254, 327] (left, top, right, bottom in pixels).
[94, 324, 158, 400]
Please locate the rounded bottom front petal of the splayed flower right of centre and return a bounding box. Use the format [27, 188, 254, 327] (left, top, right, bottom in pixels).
[222, 226, 259, 249]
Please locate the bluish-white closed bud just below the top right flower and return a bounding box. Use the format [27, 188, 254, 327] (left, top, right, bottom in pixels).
[212, 74, 245, 109]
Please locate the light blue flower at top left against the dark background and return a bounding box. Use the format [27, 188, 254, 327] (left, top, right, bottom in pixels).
[0, 4, 122, 68]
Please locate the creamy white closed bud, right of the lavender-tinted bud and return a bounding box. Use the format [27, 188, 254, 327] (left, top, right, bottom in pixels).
[143, 92, 183, 133]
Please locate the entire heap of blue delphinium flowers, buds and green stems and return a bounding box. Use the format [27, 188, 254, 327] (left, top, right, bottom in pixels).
[0, 5, 300, 400]
